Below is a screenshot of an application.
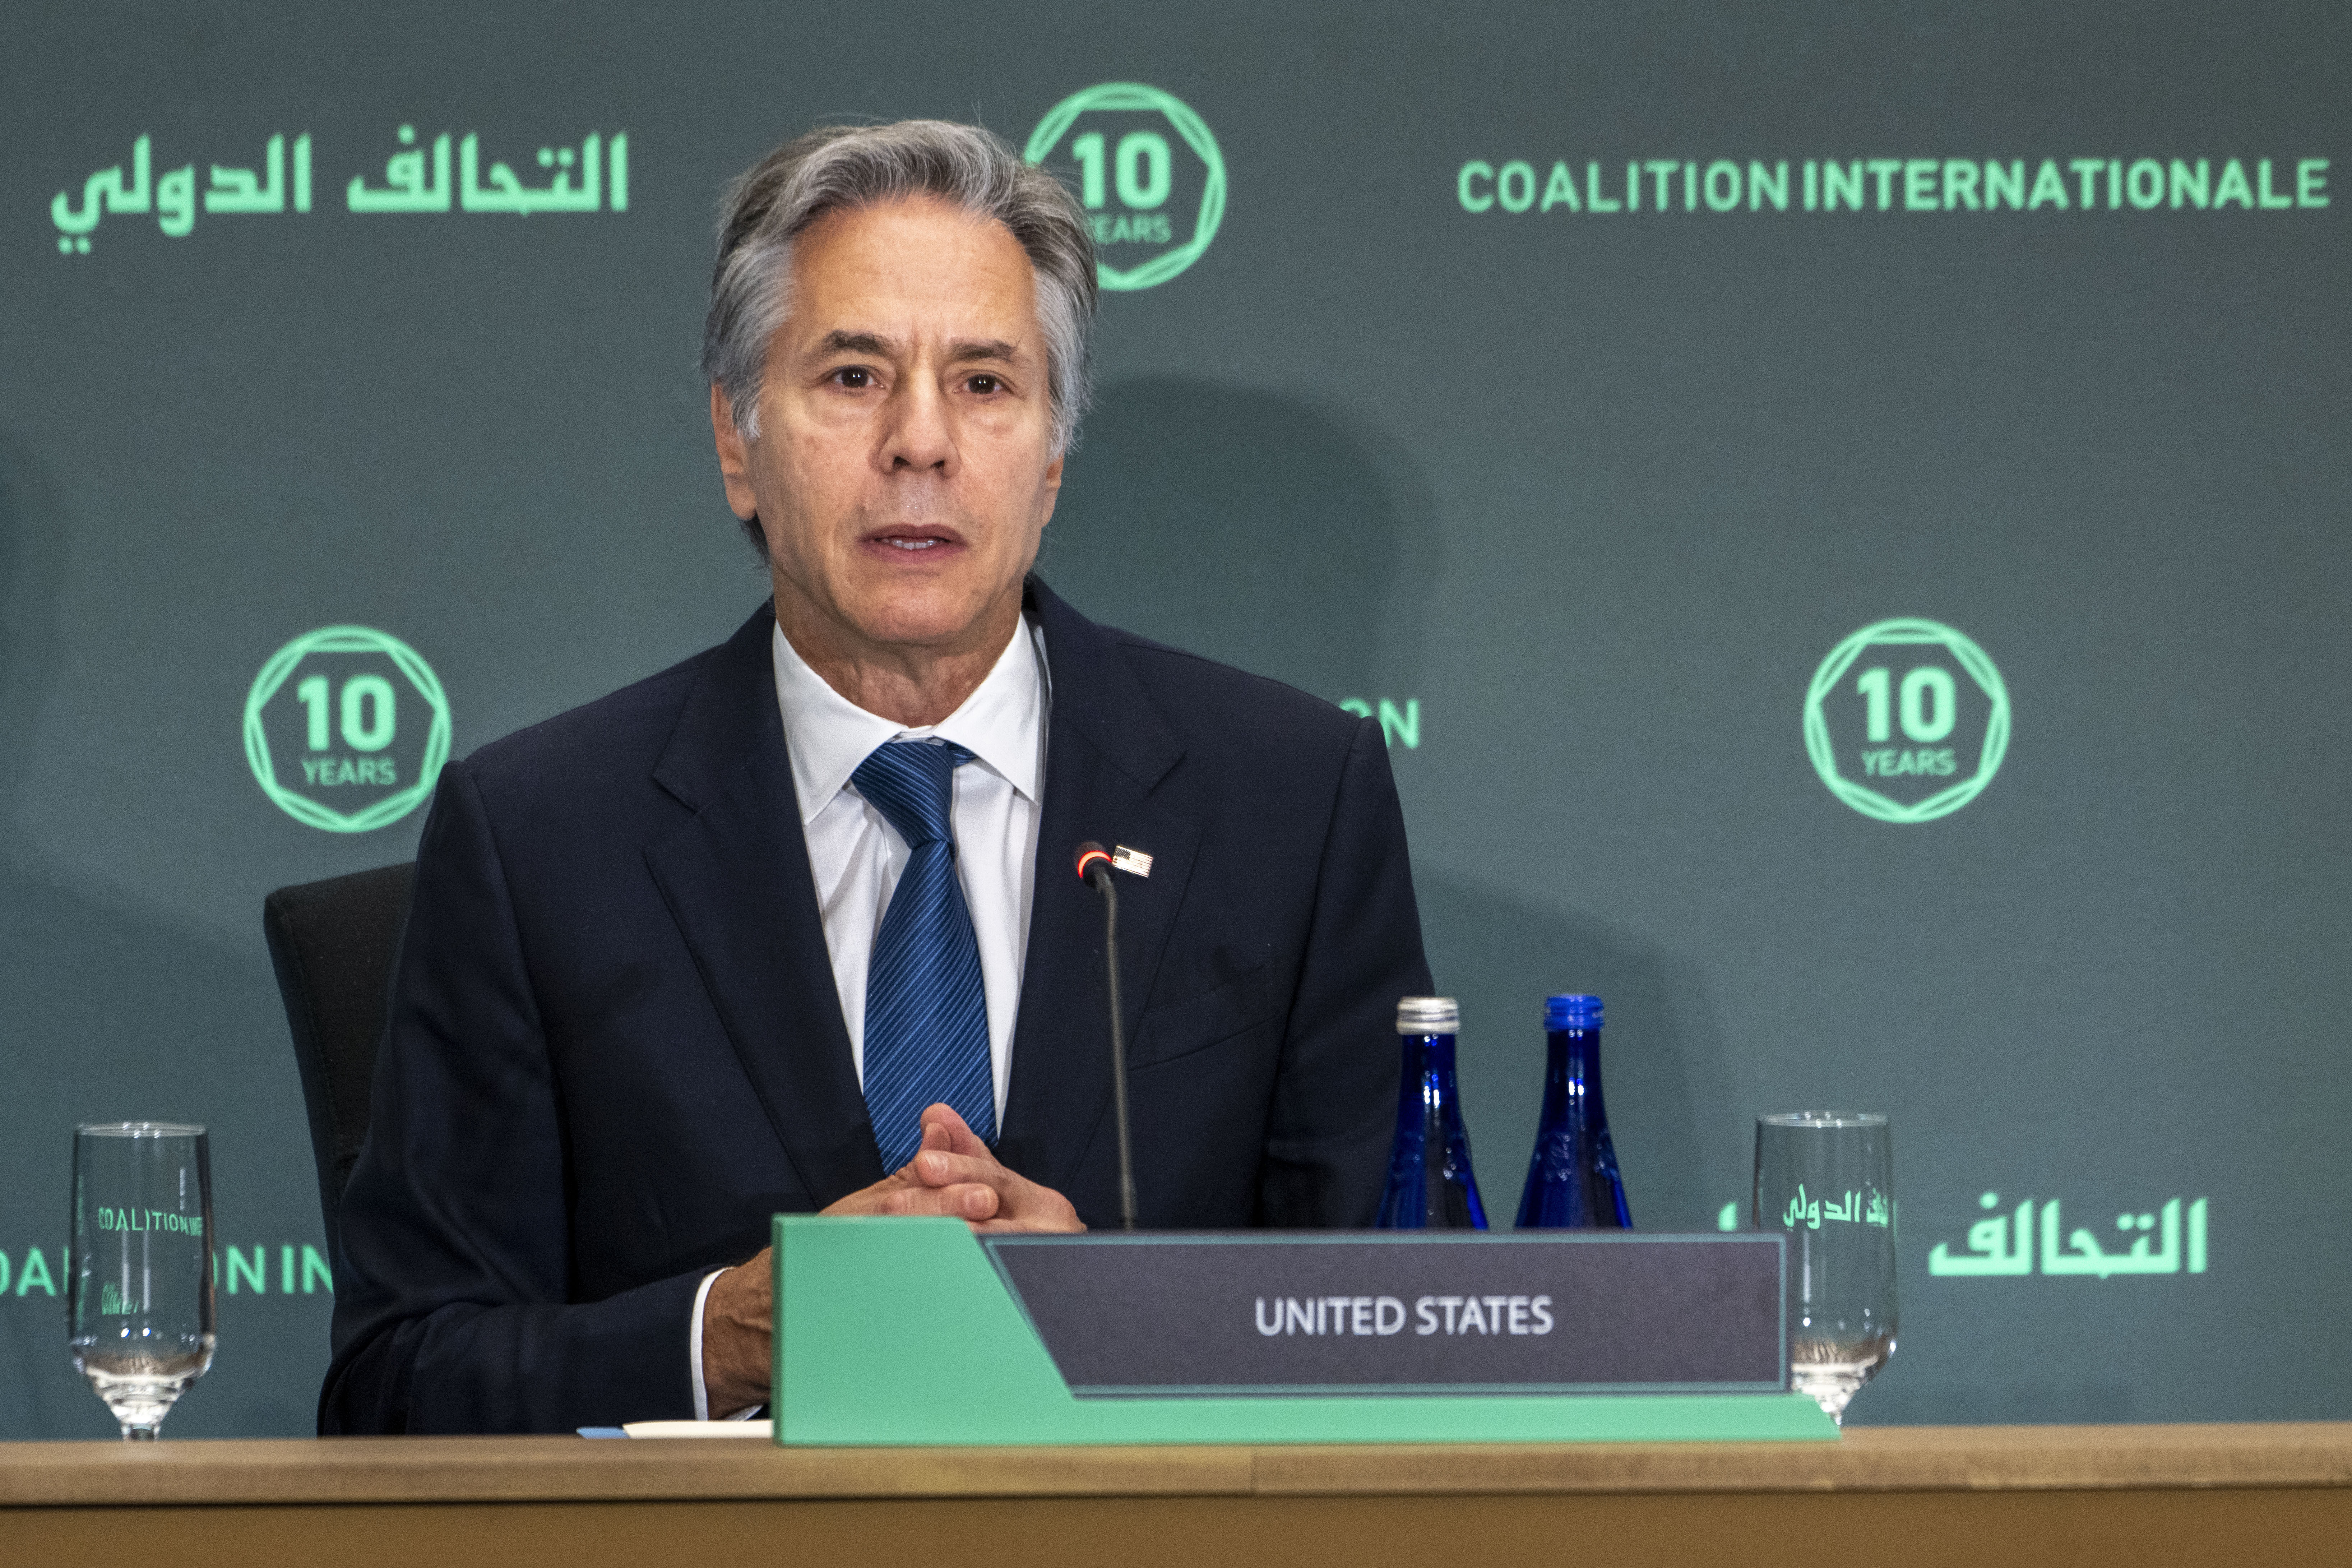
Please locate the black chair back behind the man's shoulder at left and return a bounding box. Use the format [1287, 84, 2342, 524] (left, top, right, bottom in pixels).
[261, 860, 416, 1258]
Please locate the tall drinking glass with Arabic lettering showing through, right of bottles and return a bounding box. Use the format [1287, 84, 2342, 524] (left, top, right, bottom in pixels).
[1755, 1110, 1896, 1425]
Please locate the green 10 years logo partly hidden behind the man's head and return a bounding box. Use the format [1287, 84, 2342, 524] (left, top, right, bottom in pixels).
[1021, 82, 1226, 289]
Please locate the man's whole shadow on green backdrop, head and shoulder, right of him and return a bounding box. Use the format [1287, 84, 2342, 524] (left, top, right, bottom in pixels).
[1037, 379, 1747, 1230]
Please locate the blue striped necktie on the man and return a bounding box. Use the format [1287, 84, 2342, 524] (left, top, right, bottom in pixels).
[849, 740, 997, 1171]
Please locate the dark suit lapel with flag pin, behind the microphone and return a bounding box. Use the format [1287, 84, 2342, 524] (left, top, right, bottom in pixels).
[997, 578, 1199, 1192]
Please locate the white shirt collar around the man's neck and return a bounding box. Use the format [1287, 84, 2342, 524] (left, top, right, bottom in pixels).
[769, 618, 1047, 825]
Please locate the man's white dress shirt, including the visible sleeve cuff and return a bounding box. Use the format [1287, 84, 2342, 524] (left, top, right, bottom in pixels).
[687, 618, 1051, 1420]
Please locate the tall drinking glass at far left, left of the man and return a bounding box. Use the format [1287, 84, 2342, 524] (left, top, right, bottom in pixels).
[66, 1121, 212, 1441]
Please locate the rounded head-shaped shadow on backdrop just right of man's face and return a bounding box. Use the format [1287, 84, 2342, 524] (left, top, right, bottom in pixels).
[1037, 379, 1439, 700]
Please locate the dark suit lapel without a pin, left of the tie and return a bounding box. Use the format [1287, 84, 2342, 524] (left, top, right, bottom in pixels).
[644, 606, 882, 1208]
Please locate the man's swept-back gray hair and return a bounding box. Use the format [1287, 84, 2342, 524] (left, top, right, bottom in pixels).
[703, 120, 1096, 503]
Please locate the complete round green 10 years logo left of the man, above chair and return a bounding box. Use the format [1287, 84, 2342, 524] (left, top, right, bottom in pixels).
[245, 625, 449, 832]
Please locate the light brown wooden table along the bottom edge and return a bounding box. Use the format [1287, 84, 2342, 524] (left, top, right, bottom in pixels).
[0, 1422, 2352, 1568]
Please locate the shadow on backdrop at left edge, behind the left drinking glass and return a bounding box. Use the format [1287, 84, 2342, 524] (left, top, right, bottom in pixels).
[0, 433, 327, 1439]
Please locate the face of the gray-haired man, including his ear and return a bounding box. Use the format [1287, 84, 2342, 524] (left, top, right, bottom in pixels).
[713, 198, 1061, 653]
